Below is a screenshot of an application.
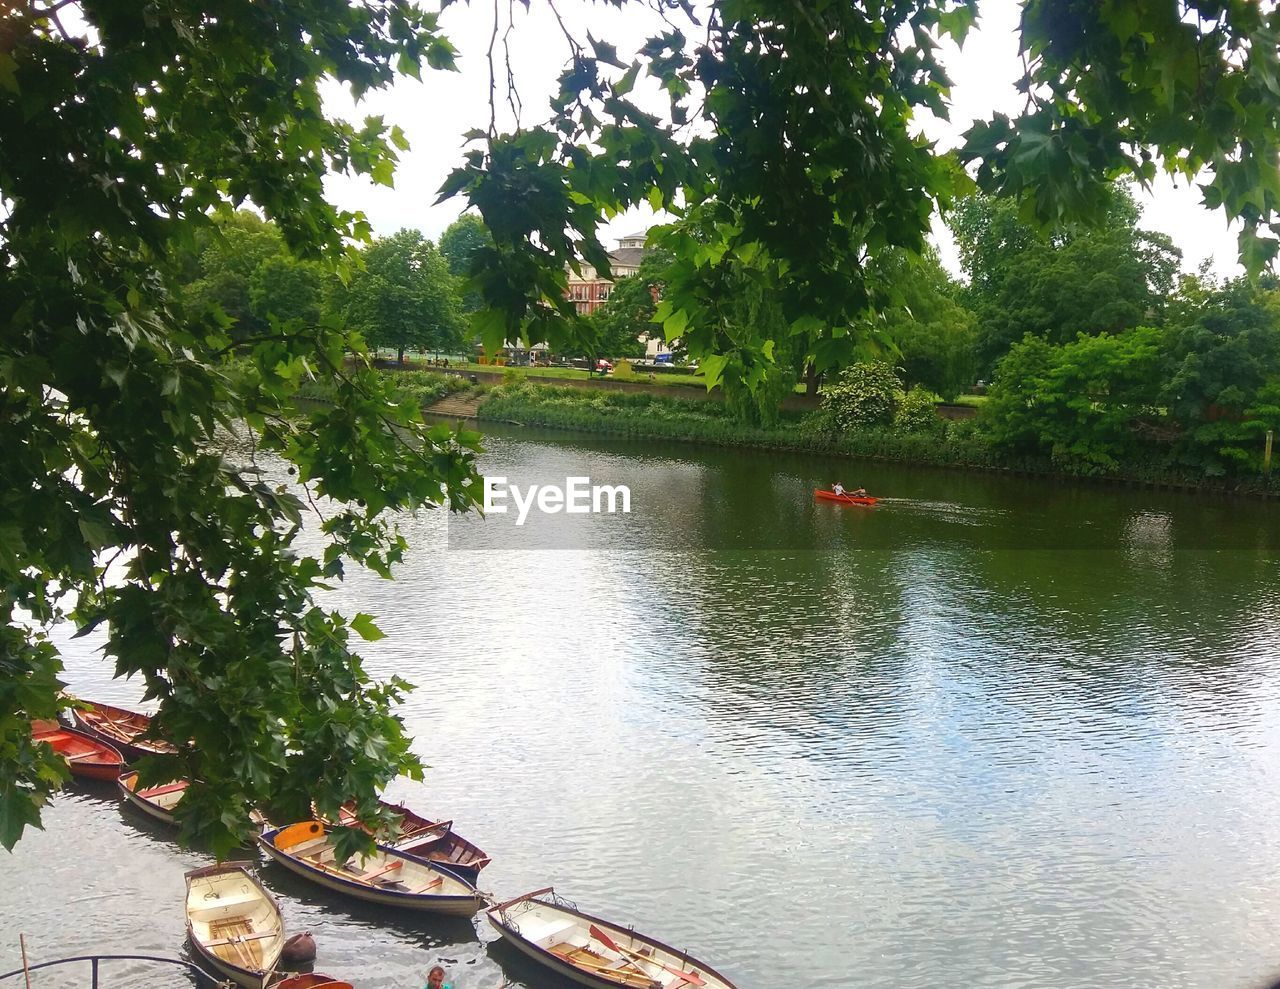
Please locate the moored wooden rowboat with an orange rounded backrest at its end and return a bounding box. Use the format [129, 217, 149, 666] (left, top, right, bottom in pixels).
[257, 820, 484, 917]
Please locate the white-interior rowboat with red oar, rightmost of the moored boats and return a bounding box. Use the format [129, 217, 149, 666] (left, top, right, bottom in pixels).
[486, 887, 735, 989]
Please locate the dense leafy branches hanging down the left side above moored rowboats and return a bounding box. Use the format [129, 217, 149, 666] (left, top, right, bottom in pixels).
[0, 0, 477, 853]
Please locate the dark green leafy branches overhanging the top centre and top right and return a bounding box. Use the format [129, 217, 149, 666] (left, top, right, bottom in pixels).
[442, 0, 1280, 406]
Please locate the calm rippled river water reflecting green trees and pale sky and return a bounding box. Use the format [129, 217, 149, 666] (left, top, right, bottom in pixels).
[0, 429, 1280, 989]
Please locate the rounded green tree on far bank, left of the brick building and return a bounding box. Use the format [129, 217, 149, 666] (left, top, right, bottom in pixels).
[338, 230, 463, 361]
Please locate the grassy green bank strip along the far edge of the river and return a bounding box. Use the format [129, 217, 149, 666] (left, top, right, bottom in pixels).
[477, 383, 1280, 496]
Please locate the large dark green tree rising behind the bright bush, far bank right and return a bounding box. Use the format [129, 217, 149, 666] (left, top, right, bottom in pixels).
[952, 187, 1180, 368]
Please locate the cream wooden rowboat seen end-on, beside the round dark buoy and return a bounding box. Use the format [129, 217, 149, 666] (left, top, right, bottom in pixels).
[187, 864, 284, 989]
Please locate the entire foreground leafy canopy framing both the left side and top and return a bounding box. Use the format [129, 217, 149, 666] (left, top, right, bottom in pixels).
[0, 0, 1280, 851]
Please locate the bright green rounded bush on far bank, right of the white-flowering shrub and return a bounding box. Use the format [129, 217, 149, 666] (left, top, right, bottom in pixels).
[982, 326, 1162, 471]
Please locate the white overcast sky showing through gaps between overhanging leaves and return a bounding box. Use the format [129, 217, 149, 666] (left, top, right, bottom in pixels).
[325, 0, 1240, 275]
